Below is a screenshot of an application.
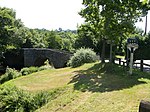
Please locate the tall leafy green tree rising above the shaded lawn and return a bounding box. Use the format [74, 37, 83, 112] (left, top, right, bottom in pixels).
[79, 0, 147, 62]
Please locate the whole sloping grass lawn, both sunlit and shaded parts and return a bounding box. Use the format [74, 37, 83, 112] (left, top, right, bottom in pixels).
[1, 62, 150, 112]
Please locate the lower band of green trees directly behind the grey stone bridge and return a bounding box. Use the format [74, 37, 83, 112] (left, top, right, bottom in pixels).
[20, 28, 76, 51]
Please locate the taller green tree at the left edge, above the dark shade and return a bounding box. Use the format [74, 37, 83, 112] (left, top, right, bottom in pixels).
[0, 7, 24, 52]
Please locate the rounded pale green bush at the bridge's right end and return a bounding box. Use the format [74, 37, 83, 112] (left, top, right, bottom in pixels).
[68, 48, 97, 67]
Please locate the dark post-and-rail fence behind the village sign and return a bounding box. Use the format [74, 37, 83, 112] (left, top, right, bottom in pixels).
[117, 58, 150, 71]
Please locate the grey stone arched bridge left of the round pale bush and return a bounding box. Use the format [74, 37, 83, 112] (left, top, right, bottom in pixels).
[23, 48, 71, 68]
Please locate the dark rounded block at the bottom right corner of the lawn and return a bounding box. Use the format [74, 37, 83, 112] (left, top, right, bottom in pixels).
[139, 100, 150, 112]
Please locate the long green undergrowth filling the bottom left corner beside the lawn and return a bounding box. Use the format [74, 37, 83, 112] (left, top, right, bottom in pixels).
[0, 84, 62, 112]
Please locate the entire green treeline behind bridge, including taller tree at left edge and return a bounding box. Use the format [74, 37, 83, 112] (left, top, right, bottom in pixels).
[0, 7, 76, 52]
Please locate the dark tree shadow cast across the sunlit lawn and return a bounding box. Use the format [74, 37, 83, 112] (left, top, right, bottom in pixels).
[69, 63, 150, 92]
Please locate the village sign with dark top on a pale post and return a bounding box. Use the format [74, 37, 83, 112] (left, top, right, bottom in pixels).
[127, 38, 139, 74]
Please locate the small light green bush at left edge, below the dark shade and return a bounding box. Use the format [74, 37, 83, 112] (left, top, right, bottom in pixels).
[0, 67, 21, 84]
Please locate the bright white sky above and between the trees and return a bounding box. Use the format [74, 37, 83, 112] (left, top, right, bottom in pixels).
[0, 0, 150, 31]
